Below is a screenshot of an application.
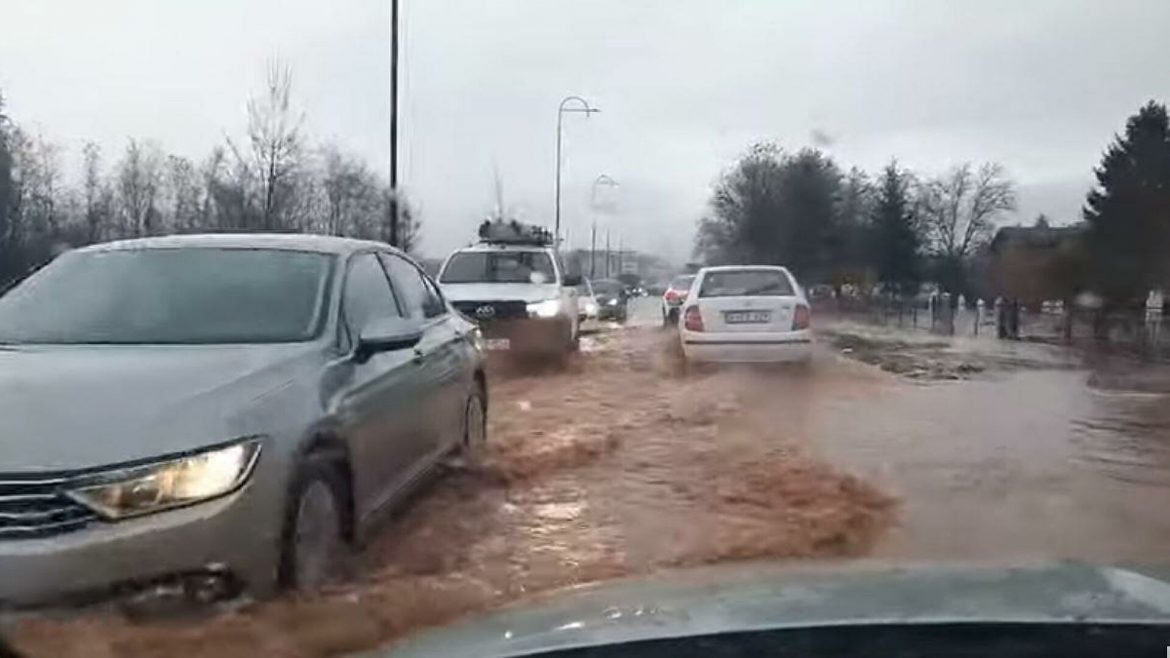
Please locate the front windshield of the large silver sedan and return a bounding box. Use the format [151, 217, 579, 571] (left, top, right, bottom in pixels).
[0, 248, 332, 344]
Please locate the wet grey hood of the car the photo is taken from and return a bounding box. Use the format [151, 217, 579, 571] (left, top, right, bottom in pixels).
[376, 563, 1170, 658]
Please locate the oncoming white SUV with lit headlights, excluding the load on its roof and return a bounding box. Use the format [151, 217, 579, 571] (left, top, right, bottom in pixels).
[439, 241, 581, 357]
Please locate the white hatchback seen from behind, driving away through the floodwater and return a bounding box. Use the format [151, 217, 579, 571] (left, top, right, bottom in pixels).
[679, 266, 812, 363]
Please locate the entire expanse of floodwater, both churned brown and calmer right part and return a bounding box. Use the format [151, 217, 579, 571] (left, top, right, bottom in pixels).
[11, 309, 1170, 658]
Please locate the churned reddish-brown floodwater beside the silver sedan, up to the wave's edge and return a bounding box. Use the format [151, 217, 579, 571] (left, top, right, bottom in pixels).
[11, 328, 896, 658]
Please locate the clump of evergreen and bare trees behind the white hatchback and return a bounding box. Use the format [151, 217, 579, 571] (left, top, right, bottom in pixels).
[695, 143, 1016, 295]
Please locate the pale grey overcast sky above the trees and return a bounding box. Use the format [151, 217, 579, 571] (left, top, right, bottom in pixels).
[0, 0, 1170, 259]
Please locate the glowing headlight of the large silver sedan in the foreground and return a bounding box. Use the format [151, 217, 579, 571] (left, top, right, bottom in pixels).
[68, 439, 260, 520]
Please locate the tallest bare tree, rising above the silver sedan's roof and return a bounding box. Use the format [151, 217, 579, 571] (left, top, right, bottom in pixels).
[228, 61, 303, 231]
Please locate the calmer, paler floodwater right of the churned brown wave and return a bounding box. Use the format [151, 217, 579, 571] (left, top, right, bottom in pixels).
[804, 320, 1170, 562]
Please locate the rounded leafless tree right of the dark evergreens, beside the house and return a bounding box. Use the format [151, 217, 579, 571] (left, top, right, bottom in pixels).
[918, 163, 1016, 260]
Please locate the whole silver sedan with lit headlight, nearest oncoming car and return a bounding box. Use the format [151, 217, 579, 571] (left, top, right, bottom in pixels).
[0, 234, 488, 605]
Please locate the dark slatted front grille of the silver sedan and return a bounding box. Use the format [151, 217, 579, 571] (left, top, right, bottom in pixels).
[0, 474, 97, 540]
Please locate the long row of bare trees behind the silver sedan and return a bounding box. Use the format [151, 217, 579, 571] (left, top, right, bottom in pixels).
[0, 63, 420, 283]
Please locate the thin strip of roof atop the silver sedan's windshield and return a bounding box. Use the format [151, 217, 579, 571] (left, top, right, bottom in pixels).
[78, 233, 397, 254]
